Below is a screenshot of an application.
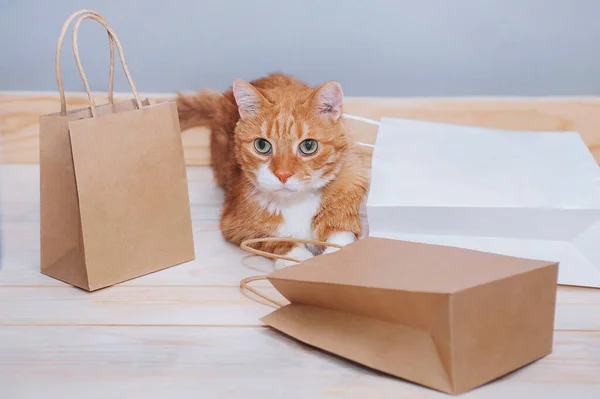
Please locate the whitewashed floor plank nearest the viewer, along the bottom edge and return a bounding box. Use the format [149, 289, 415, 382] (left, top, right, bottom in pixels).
[0, 327, 600, 399]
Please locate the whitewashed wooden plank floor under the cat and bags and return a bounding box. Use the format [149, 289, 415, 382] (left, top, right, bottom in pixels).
[0, 165, 600, 399]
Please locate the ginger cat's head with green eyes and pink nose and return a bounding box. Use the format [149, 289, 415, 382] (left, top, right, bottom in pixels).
[233, 79, 348, 197]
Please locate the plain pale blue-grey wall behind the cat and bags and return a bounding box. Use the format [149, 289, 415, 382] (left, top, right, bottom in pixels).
[0, 0, 600, 96]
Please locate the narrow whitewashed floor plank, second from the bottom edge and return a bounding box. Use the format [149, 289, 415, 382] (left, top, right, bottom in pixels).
[0, 283, 600, 331]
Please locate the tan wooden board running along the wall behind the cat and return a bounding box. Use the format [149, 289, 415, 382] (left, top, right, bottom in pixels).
[0, 92, 600, 165]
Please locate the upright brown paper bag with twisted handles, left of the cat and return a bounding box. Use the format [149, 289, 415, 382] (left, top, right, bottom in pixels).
[40, 10, 194, 291]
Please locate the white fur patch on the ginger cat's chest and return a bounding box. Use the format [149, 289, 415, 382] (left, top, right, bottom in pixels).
[267, 192, 321, 239]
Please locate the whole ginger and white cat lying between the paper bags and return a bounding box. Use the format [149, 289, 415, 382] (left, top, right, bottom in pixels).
[177, 74, 368, 268]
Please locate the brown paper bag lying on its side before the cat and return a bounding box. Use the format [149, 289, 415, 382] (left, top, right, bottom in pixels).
[241, 238, 558, 394]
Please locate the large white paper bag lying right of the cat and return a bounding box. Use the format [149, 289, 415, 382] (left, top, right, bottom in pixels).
[367, 118, 600, 287]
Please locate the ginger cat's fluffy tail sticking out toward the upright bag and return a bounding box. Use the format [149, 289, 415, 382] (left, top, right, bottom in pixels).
[177, 90, 221, 131]
